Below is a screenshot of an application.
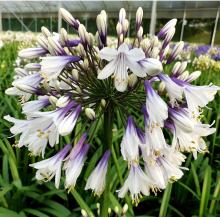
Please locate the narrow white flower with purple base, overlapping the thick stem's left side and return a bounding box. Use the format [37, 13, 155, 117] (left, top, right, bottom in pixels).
[85, 150, 110, 196]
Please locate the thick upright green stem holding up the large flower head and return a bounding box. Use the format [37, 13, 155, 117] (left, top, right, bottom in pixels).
[100, 106, 114, 217]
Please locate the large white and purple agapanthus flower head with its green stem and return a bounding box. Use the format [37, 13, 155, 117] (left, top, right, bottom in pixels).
[5, 8, 220, 216]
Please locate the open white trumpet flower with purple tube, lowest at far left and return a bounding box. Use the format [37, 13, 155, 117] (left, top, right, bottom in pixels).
[30, 144, 71, 188]
